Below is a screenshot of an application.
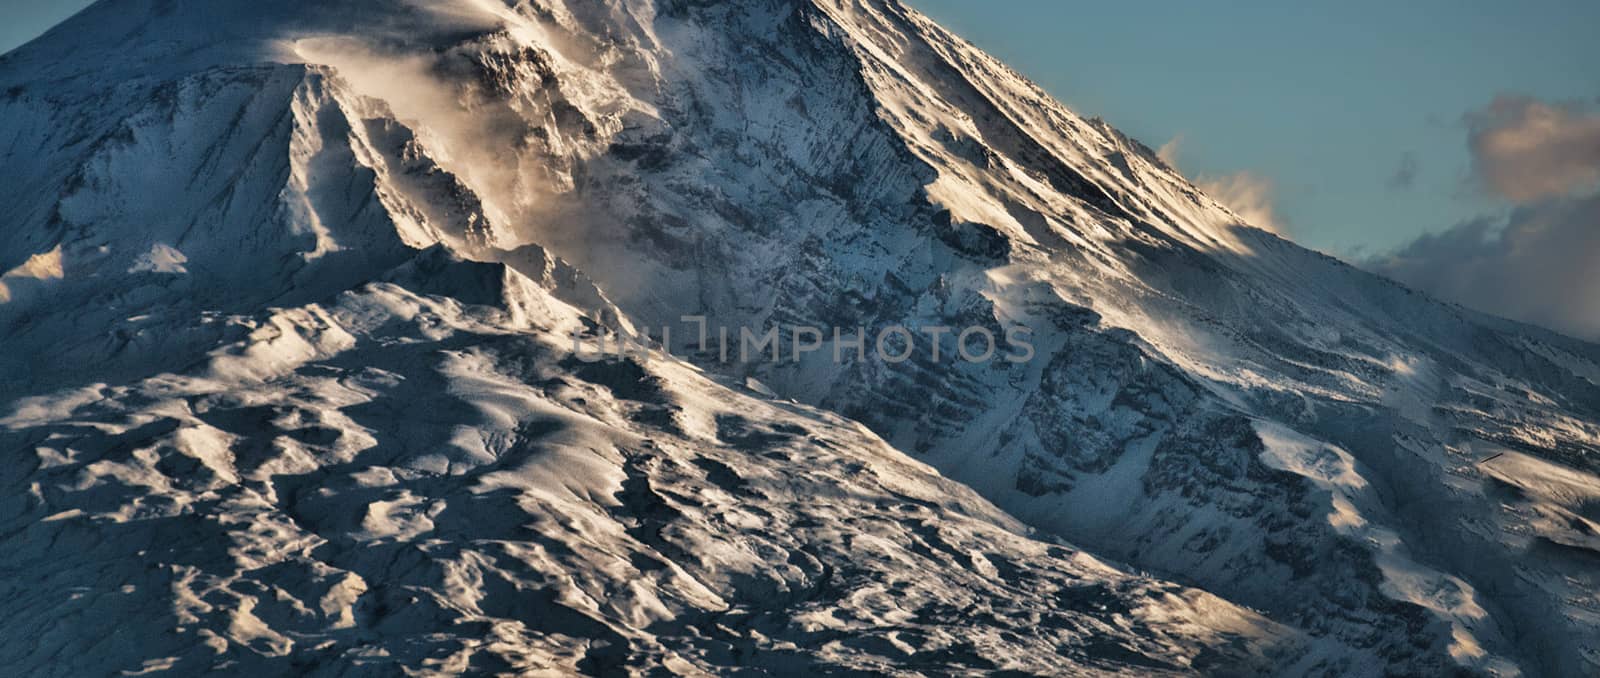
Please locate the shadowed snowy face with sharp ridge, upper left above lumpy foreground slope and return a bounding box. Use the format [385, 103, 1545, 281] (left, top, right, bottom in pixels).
[0, 66, 480, 384]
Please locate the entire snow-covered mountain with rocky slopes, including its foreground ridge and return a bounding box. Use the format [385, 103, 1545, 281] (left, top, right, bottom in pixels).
[0, 0, 1600, 676]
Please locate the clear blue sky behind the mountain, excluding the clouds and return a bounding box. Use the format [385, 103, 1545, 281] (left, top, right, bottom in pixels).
[0, 0, 1600, 256]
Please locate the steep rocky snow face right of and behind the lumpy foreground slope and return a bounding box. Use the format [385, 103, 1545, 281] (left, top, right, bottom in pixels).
[262, 2, 1600, 675]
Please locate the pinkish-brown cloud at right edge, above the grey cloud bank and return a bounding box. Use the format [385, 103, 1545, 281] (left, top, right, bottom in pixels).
[1466, 96, 1600, 203]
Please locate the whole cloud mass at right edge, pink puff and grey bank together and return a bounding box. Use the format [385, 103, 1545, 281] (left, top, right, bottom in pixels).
[1363, 96, 1600, 341]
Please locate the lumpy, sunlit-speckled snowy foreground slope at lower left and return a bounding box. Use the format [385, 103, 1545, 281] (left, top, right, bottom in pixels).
[0, 248, 1304, 675]
